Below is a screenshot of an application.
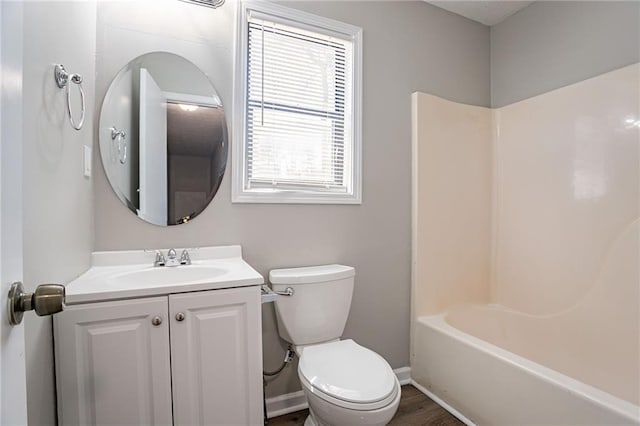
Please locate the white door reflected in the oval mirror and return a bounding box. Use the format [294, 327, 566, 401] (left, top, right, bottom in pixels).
[139, 68, 169, 225]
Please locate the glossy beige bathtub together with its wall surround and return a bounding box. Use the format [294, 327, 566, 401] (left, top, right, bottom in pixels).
[411, 64, 640, 424]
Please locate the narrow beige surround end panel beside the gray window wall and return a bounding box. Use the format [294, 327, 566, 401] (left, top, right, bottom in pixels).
[412, 93, 493, 316]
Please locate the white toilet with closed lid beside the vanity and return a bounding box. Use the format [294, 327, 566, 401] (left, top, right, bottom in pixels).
[269, 265, 400, 426]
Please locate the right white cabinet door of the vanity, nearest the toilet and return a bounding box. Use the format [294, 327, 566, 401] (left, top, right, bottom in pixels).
[169, 287, 263, 426]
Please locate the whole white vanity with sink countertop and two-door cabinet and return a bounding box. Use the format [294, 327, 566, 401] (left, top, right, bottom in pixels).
[53, 246, 264, 425]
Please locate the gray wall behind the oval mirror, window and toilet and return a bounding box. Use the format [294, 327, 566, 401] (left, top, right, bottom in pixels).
[94, 1, 490, 396]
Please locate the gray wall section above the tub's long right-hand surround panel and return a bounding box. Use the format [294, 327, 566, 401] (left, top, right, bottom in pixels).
[491, 1, 640, 107]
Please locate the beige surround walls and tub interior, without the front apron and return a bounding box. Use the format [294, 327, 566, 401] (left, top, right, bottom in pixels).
[412, 64, 640, 406]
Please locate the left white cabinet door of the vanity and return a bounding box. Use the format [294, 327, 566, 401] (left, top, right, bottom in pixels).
[54, 297, 172, 425]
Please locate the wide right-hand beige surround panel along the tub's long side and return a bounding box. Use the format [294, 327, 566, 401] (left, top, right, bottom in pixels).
[491, 65, 640, 316]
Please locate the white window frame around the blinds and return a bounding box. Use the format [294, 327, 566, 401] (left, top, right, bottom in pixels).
[231, 0, 362, 204]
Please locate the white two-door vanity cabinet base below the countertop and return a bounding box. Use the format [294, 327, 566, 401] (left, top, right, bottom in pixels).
[54, 286, 263, 425]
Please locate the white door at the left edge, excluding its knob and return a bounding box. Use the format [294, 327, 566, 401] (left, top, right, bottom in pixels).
[0, 2, 27, 425]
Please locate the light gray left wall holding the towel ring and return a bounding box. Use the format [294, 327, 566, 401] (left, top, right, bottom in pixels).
[22, 2, 96, 425]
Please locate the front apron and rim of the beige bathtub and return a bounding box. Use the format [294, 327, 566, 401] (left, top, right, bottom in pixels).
[411, 314, 640, 426]
